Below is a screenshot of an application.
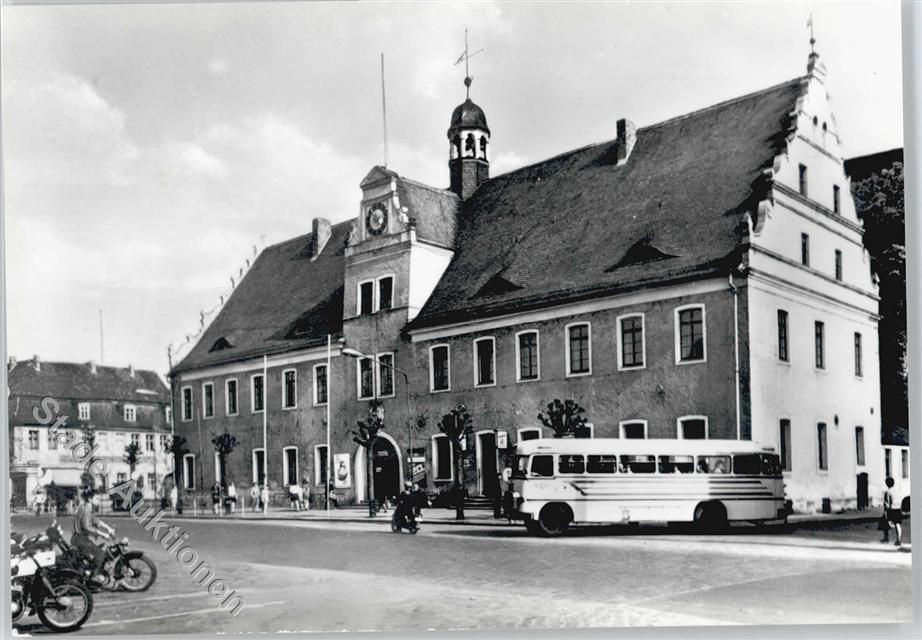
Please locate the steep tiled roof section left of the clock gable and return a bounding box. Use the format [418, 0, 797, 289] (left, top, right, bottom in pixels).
[173, 221, 352, 373]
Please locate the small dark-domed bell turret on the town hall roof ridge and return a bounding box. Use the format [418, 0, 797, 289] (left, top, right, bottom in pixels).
[448, 76, 490, 200]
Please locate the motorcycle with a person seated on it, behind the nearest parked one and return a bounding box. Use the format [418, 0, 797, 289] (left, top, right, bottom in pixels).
[45, 521, 157, 592]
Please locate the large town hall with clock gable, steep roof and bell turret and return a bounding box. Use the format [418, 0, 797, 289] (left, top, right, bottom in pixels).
[171, 47, 883, 511]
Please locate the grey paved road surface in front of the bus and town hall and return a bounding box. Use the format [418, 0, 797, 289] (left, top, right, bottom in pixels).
[13, 517, 912, 635]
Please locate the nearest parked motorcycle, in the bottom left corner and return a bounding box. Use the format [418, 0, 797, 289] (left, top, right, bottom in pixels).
[10, 534, 93, 633]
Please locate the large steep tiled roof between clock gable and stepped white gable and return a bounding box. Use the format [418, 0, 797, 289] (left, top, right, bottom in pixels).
[409, 78, 804, 329]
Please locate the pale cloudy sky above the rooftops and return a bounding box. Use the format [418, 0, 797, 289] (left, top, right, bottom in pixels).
[0, 2, 903, 374]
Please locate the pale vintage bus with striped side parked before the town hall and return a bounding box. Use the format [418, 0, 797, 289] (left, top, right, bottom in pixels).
[512, 438, 789, 536]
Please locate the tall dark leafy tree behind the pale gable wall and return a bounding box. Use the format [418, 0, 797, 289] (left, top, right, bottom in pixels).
[852, 162, 909, 434]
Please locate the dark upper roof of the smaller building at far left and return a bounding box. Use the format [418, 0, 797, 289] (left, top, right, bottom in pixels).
[9, 360, 170, 403]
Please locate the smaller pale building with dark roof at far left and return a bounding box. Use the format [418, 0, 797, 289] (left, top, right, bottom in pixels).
[8, 356, 173, 506]
